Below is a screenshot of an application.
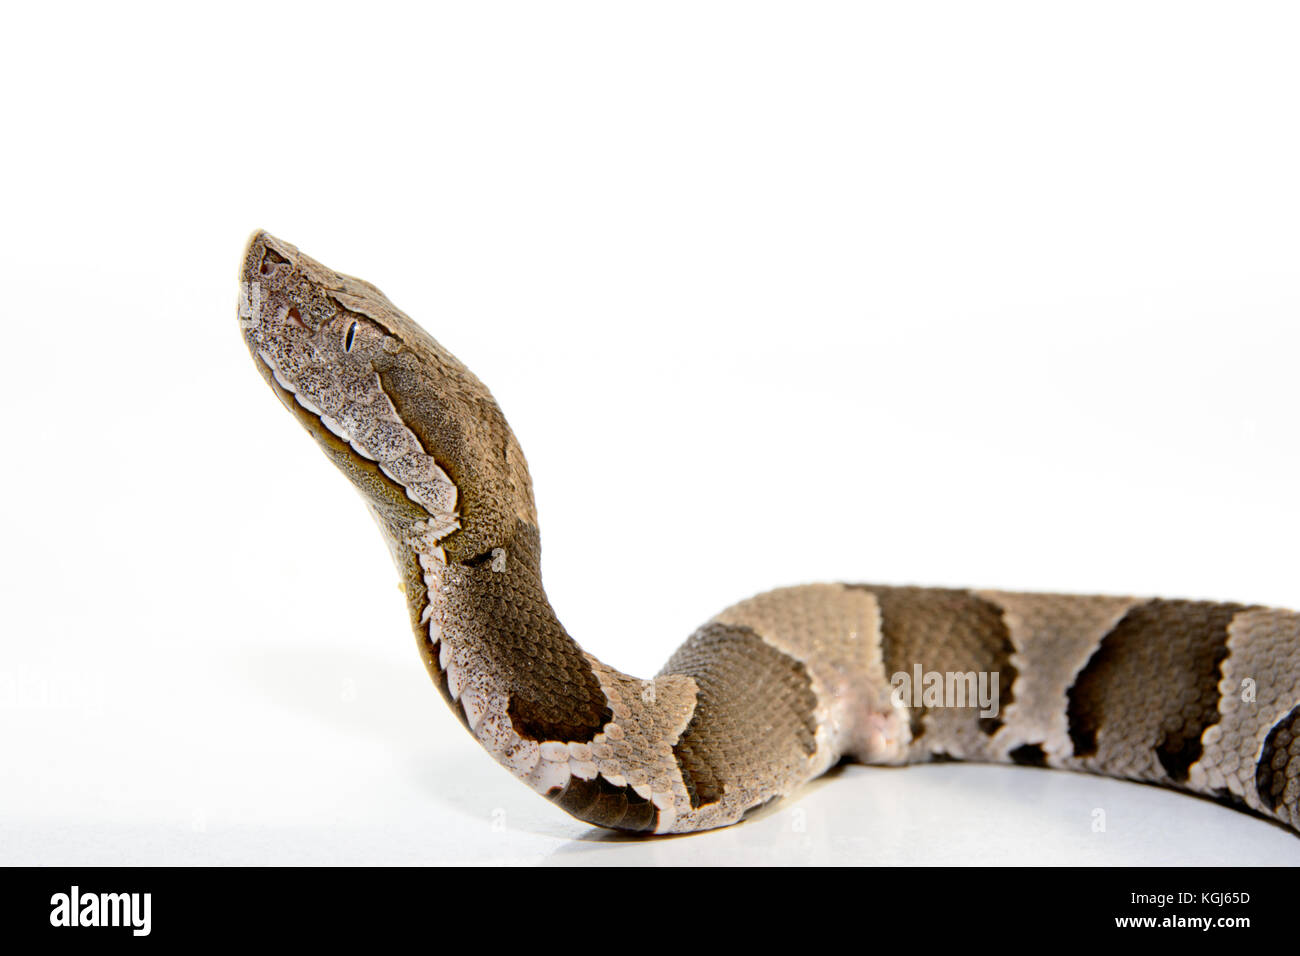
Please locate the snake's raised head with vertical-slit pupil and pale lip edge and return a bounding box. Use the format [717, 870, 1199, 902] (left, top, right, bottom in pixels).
[239, 232, 537, 561]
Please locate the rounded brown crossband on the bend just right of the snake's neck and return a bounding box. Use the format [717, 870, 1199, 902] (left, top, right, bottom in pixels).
[662, 623, 816, 808]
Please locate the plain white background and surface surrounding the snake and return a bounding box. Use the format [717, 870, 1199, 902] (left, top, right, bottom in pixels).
[0, 3, 1300, 865]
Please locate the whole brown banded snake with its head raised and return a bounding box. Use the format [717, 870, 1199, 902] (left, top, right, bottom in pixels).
[238, 230, 1300, 834]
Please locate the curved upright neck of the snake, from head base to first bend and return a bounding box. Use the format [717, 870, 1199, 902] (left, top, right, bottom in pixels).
[408, 519, 712, 831]
